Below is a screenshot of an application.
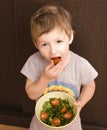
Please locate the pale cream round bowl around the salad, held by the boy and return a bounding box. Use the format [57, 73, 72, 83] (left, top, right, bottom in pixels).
[35, 92, 78, 129]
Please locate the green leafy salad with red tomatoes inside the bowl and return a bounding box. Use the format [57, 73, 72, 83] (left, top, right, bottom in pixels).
[40, 98, 74, 127]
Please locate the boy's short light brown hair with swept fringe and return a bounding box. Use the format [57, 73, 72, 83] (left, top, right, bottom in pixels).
[30, 5, 72, 46]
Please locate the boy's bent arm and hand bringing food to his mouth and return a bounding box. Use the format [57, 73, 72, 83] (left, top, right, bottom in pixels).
[25, 61, 63, 100]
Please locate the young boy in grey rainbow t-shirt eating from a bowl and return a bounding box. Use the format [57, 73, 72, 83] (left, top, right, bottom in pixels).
[21, 5, 98, 130]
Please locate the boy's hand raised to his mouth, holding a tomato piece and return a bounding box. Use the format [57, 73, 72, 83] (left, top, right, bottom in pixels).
[42, 60, 64, 80]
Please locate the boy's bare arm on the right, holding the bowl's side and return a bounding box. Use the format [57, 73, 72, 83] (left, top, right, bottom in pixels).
[76, 81, 95, 110]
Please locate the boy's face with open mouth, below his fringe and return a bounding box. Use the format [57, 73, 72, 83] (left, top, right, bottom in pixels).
[37, 27, 73, 62]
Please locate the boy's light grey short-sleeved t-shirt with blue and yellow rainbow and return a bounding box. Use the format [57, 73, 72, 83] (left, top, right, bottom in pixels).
[21, 52, 98, 130]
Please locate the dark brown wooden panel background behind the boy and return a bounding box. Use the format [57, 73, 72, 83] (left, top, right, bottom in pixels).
[0, 0, 107, 130]
